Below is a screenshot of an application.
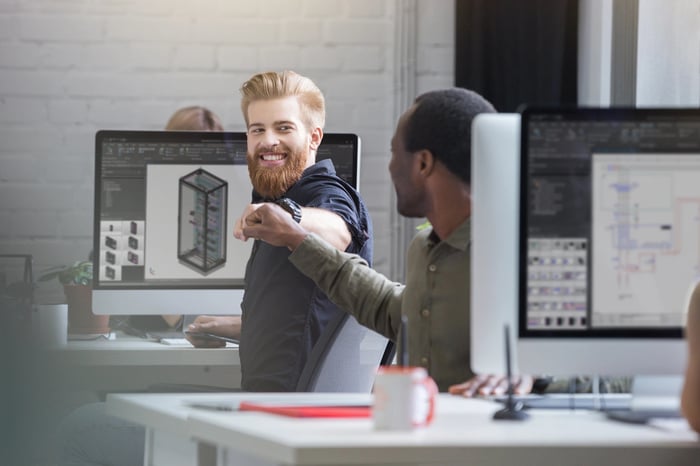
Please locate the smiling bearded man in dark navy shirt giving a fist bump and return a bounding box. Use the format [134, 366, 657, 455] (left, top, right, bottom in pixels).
[183, 71, 372, 392]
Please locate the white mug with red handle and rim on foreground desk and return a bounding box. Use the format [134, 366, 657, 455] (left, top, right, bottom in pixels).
[372, 366, 438, 430]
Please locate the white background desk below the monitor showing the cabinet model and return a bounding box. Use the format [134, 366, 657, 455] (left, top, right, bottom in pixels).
[46, 335, 241, 393]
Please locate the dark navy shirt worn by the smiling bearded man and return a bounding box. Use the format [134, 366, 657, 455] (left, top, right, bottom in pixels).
[239, 160, 372, 392]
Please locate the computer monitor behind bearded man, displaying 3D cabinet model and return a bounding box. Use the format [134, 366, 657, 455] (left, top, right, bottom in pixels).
[92, 130, 360, 315]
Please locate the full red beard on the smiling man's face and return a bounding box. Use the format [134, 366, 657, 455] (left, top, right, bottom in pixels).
[248, 148, 306, 199]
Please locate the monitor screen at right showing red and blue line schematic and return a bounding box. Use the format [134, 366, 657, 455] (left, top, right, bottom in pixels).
[520, 109, 700, 336]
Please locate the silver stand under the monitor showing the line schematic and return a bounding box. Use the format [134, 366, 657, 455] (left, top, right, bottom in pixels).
[607, 375, 683, 424]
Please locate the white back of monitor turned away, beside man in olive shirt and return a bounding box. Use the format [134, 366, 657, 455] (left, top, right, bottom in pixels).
[470, 113, 520, 374]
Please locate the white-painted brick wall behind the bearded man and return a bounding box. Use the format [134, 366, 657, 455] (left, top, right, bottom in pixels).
[0, 0, 454, 290]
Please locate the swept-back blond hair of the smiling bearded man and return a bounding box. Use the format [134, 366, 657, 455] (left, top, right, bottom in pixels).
[240, 71, 326, 130]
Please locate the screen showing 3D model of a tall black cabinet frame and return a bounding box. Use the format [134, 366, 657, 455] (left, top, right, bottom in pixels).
[94, 131, 252, 288]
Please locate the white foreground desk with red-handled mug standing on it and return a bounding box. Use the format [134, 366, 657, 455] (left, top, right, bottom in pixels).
[107, 394, 700, 466]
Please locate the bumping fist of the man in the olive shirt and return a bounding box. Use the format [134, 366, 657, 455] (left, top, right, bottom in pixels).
[242, 203, 308, 250]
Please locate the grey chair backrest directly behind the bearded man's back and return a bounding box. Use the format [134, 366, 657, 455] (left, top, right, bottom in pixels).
[296, 313, 394, 393]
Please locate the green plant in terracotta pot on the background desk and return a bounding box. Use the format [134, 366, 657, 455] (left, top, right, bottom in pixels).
[39, 260, 109, 334]
